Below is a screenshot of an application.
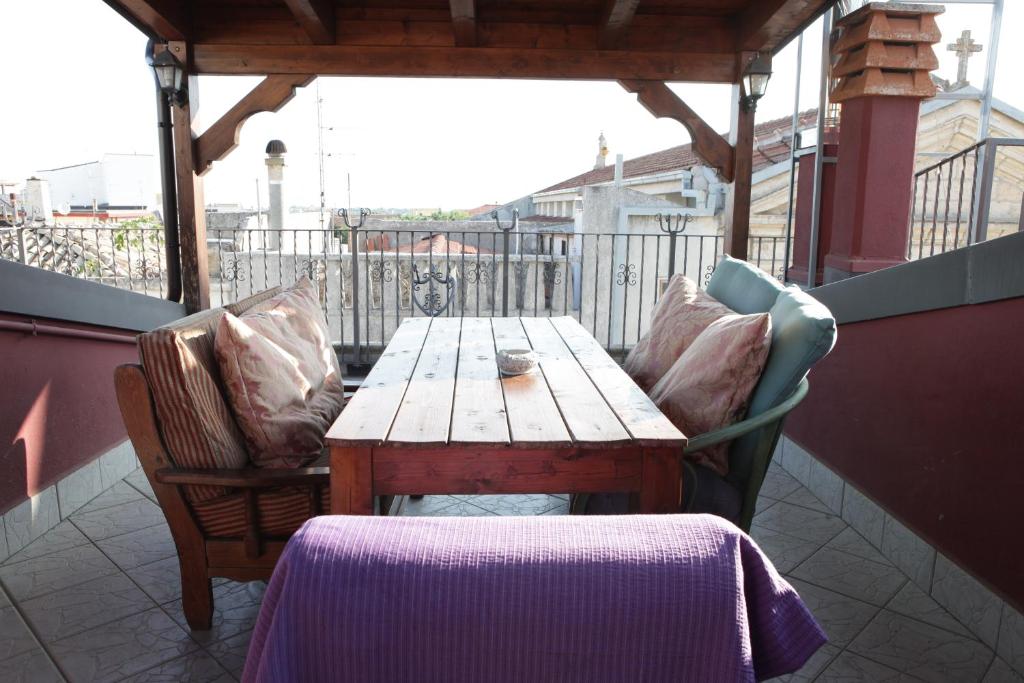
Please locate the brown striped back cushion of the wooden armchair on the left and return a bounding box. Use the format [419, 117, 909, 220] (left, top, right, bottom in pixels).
[138, 308, 249, 502]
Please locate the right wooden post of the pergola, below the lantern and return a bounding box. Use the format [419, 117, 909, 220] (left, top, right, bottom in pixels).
[725, 84, 754, 260]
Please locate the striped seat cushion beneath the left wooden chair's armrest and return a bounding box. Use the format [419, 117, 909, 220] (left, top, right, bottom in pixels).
[193, 484, 331, 539]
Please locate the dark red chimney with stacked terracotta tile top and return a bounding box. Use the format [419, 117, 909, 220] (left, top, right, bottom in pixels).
[822, 2, 943, 283]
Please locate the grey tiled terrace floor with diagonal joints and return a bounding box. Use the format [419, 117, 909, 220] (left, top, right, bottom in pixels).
[0, 467, 1024, 683]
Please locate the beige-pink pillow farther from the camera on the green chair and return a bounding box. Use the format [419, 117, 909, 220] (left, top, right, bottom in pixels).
[623, 274, 733, 392]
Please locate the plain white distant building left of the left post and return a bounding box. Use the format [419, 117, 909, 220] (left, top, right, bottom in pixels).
[37, 154, 158, 220]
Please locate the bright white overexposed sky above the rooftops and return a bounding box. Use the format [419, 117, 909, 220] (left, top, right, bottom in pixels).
[0, 0, 1024, 210]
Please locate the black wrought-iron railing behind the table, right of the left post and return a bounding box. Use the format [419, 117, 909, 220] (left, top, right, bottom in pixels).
[208, 226, 784, 364]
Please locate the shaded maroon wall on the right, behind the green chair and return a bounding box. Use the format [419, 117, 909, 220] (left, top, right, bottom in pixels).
[785, 298, 1024, 609]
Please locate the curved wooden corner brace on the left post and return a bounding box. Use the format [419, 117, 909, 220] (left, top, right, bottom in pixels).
[196, 74, 316, 175]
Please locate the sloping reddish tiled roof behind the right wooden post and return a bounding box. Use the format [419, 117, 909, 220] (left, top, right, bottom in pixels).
[538, 109, 818, 193]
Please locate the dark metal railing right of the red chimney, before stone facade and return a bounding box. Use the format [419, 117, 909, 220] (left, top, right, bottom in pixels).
[906, 137, 1024, 259]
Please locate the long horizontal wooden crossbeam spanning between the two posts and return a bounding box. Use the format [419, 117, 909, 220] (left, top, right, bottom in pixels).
[194, 44, 738, 83]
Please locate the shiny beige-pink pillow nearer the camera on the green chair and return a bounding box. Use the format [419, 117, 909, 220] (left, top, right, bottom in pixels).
[650, 313, 771, 476]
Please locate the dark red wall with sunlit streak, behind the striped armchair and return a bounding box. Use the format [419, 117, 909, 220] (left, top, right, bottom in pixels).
[0, 314, 138, 512]
